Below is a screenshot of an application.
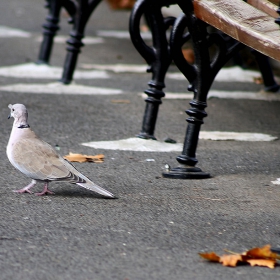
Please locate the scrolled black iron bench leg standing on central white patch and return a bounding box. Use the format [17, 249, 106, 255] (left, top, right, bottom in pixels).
[129, 0, 175, 139]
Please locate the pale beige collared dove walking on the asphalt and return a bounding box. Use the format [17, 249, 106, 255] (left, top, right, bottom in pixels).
[7, 104, 114, 198]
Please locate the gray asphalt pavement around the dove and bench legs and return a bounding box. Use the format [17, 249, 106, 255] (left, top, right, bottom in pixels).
[0, 0, 280, 280]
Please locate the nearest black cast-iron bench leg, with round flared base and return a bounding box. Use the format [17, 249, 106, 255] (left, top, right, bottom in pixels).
[163, 0, 244, 179]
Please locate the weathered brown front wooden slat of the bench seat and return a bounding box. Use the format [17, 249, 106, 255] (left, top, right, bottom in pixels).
[193, 0, 280, 61]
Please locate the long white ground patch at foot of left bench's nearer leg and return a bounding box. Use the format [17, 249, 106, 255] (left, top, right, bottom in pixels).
[0, 82, 123, 95]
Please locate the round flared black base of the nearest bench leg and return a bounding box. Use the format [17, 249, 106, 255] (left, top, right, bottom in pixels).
[162, 167, 211, 179]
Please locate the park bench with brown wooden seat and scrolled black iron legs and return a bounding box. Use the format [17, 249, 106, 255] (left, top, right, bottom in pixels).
[131, 0, 280, 179]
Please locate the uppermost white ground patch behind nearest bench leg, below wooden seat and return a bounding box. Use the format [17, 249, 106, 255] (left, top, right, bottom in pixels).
[166, 66, 261, 83]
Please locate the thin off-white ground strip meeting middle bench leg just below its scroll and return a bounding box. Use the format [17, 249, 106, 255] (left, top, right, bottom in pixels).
[80, 64, 148, 73]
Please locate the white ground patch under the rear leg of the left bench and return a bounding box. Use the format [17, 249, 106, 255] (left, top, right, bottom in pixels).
[0, 63, 110, 79]
